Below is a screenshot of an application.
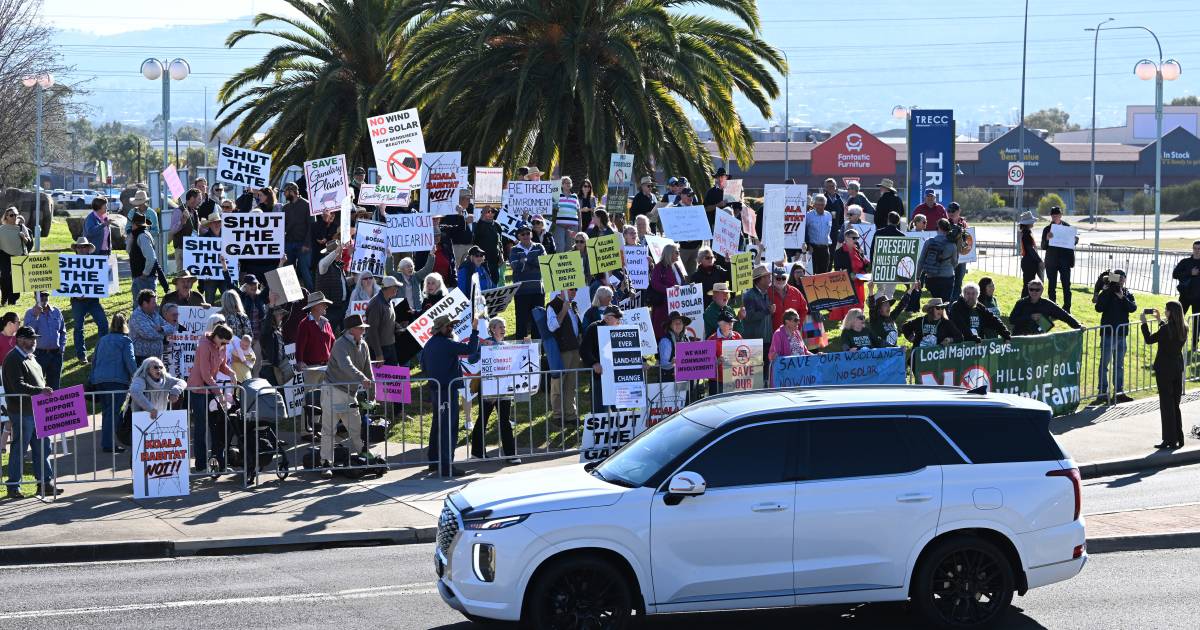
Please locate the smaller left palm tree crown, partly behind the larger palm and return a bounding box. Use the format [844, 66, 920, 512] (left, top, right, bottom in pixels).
[212, 0, 424, 176]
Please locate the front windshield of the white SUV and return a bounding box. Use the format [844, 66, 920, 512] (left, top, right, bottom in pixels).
[594, 415, 709, 487]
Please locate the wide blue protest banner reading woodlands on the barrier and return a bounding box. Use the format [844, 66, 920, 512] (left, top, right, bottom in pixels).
[770, 348, 905, 388]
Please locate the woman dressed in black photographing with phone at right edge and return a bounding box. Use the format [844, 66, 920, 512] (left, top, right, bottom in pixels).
[1141, 300, 1188, 449]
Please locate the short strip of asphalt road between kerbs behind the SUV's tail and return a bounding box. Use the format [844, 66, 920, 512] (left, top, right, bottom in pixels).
[1084, 464, 1200, 515]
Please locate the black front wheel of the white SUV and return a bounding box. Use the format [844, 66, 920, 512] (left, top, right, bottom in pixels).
[526, 556, 634, 630]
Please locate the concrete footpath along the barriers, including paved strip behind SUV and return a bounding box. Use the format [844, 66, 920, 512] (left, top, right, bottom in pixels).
[0, 396, 1200, 565]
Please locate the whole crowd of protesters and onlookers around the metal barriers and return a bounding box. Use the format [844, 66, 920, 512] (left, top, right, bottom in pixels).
[0, 167, 1200, 496]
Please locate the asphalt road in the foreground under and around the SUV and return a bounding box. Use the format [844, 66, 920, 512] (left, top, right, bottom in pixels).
[0, 545, 1200, 630]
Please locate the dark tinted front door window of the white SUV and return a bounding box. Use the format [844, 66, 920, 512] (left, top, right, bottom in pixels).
[683, 422, 797, 490]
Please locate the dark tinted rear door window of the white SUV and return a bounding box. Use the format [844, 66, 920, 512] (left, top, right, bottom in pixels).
[800, 418, 925, 480]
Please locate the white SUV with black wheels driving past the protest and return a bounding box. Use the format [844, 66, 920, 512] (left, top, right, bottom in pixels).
[434, 386, 1087, 629]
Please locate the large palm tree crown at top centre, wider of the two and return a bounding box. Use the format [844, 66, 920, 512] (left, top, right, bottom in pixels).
[396, 0, 786, 194]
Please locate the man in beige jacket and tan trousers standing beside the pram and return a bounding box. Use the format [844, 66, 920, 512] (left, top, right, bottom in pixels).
[320, 313, 374, 479]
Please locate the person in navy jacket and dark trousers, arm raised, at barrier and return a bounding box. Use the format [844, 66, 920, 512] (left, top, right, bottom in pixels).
[421, 313, 487, 476]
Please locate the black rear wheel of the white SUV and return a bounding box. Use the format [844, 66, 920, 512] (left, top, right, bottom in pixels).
[912, 536, 1015, 628]
